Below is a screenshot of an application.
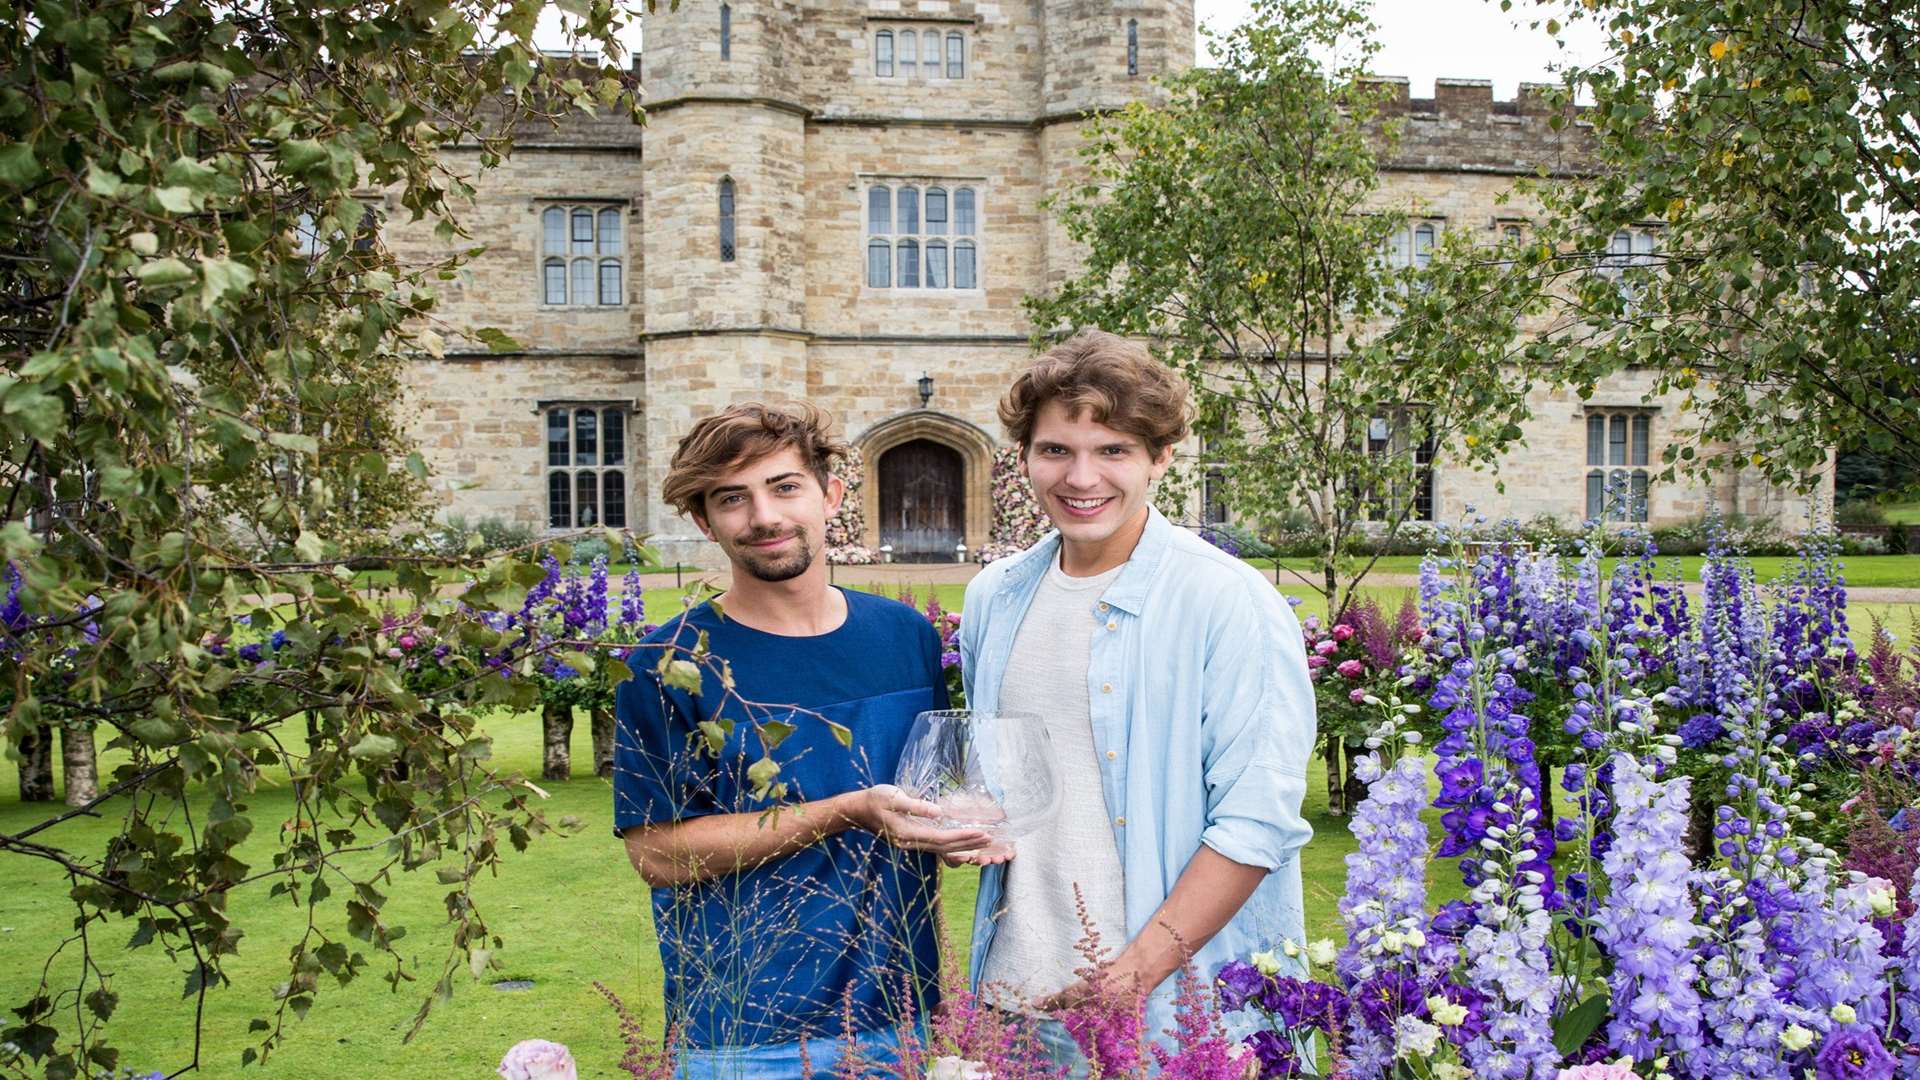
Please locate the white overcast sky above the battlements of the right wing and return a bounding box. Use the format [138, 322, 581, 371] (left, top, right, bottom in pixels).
[1194, 0, 1603, 100]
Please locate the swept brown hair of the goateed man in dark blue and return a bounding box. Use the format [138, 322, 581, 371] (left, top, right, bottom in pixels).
[660, 402, 847, 519]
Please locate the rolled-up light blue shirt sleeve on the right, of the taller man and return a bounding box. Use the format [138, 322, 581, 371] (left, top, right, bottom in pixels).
[1200, 582, 1315, 871]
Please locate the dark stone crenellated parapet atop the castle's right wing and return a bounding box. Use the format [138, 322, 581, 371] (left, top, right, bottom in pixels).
[1369, 75, 1592, 175]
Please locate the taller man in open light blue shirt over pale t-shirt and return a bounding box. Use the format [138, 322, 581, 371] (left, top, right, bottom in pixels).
[960, 331, 1315, 1074]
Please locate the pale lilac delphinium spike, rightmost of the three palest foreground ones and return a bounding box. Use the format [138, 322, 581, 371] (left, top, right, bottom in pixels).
[1594, 753, 1701, 1059]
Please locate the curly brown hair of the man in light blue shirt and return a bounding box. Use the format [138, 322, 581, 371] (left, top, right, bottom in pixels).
[1000, 322, 1192, 449]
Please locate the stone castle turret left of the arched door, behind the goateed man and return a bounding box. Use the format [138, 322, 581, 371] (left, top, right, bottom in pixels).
[636, 0, 808, 559]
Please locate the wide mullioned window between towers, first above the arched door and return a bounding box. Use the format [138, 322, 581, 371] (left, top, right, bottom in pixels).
[866, 184, 979, 288]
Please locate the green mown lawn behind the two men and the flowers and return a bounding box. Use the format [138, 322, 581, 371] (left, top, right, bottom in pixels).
[0, 691, 1459, 1080]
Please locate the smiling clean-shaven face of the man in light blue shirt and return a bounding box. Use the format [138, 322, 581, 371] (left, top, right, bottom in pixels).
[1020, 400, 1173, 575]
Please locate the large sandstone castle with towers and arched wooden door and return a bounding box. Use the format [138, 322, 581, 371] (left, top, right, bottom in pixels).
[386, 0, 1807, 563]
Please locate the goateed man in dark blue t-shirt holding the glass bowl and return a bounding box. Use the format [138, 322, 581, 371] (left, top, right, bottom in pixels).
[614, 404, 989, 1078]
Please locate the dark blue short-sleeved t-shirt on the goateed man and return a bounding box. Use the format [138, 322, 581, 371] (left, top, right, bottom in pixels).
[612, 590, 947, 1047]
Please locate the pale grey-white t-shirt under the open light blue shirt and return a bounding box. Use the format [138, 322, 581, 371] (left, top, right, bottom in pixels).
[981, 549, 1127, 1007]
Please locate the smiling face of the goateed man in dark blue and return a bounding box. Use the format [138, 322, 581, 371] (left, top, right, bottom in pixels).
[693, 448, 843, 582]
